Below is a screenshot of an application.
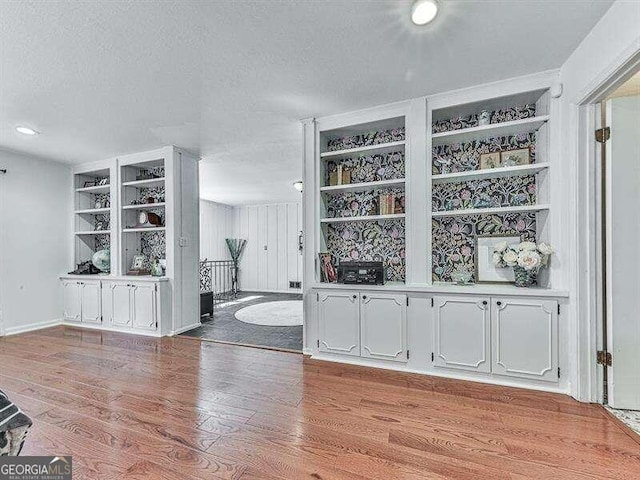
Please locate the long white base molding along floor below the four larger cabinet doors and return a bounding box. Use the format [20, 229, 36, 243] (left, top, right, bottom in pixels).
[310, 353, 570, 395]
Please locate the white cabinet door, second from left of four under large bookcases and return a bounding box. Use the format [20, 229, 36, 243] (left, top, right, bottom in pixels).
[360, 292, 407, 362]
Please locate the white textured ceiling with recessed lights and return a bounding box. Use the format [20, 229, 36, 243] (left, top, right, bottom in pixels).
[0, 0, 612, 204]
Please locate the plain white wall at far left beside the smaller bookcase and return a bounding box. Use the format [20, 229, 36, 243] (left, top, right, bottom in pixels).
[0, 150, 73, 334]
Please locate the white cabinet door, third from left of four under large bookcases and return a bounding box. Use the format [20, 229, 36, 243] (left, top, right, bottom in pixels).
[433, 297, 491, 372]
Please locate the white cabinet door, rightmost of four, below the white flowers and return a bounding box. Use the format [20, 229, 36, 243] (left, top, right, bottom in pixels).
[491, 298, 558, 382]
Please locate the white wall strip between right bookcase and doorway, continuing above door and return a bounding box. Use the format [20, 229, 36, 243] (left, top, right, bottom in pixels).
[554, 0, 640, 402]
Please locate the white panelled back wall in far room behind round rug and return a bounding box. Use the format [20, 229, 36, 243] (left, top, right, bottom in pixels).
[235, 203, 302, 292]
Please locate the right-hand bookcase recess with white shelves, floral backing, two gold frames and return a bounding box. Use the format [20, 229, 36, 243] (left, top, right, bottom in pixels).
[427, 89, 552, 283]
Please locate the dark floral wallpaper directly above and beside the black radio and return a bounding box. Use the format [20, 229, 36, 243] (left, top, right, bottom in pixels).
[327, 220, 406, 282]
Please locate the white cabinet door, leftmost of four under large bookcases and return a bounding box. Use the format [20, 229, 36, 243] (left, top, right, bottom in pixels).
[318, 292, 360, 356]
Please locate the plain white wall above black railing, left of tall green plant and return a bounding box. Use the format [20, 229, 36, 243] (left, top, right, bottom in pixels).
[200, 200, 235, 260]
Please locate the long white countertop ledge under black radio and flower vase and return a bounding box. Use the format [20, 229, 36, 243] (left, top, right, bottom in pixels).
[311, 282, 569, 298]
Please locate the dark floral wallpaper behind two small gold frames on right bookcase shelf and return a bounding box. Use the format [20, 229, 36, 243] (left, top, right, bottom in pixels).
[431, 133, 536, 175]
